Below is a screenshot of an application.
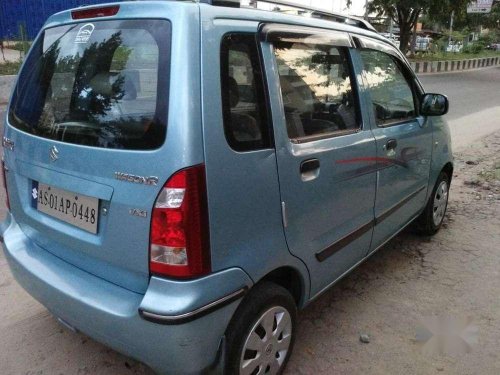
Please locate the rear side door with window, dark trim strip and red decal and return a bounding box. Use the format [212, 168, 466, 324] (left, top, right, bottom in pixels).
[262, 25, 376, 296]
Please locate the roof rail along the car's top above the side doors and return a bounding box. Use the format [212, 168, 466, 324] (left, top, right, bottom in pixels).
[199, 0, 377, 32]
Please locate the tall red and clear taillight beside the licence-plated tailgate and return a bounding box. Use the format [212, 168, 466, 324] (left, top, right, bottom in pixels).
[149, 165, 211, 278]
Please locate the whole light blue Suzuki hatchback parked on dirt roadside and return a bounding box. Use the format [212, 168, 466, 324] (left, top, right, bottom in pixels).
[0, 0, 453, 374]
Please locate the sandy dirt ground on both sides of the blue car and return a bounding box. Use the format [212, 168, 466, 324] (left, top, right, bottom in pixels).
[0, 132, 500, 375]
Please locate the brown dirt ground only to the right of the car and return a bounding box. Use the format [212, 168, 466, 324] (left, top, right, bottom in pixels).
[287, 132, 500, 375]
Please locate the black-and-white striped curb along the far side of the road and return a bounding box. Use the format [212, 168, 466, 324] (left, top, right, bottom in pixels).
[410, 57, 500, 74]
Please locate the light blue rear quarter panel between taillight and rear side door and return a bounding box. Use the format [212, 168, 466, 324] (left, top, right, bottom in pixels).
[200, 4, 309, 306]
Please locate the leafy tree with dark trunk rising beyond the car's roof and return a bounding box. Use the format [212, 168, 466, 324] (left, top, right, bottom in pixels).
[368, 0, 470, 53]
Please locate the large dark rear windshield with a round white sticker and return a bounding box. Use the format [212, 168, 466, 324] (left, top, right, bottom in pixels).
[9, 20, 171, 150]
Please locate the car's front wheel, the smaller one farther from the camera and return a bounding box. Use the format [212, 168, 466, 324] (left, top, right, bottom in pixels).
[416, 172, 450, 236]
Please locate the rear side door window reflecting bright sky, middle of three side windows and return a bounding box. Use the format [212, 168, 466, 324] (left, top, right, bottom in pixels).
[274, 40, 360, 141]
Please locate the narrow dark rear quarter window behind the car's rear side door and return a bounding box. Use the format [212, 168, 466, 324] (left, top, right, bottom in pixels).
[221, 34, 271, 151]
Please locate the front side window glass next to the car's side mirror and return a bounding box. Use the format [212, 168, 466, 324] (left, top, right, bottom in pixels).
[361, 50, 417, 126]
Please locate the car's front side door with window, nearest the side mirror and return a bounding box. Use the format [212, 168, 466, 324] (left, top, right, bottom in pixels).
[360, 49, 432, 251]
